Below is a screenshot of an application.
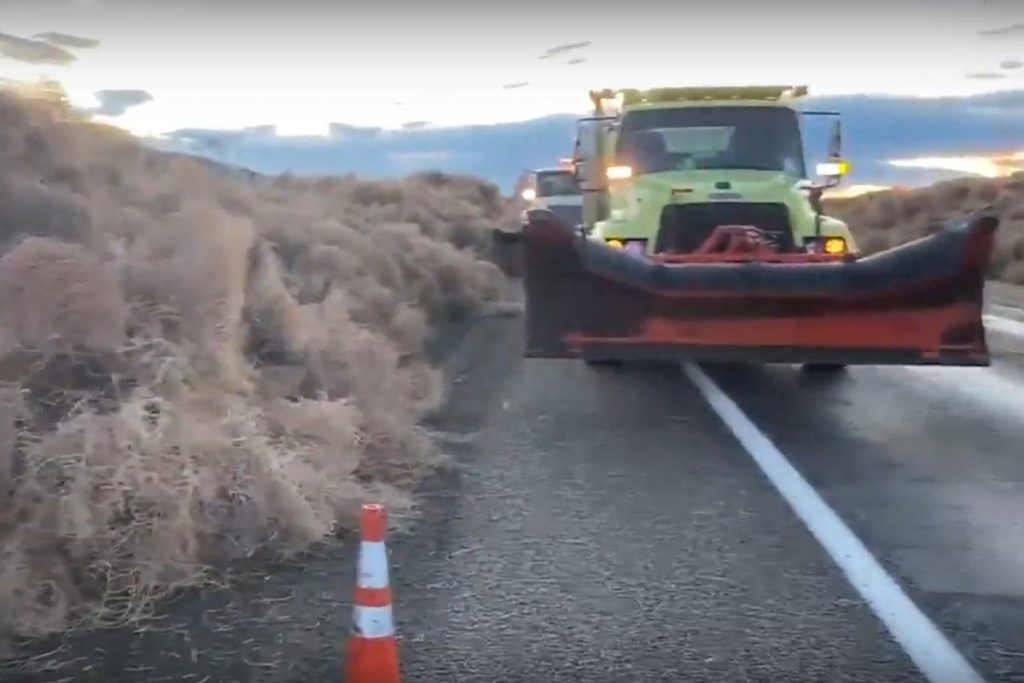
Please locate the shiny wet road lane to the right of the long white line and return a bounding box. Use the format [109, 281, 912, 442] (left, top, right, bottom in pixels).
[713, 360, 1024, 681]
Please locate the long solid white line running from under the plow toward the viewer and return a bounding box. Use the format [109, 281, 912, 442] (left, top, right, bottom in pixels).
[683, 364, 984, 683]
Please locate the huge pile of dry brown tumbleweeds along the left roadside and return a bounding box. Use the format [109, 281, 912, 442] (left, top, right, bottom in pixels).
[0, 92, 515, 646]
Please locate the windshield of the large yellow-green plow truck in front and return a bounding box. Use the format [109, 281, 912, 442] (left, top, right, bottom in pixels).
[615, 106, 806, 177]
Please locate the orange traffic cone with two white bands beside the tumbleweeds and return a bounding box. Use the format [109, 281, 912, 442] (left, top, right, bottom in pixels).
[343, 504, 401, 683]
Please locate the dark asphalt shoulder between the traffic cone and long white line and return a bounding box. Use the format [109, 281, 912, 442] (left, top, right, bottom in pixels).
[398, 331, 921, 681]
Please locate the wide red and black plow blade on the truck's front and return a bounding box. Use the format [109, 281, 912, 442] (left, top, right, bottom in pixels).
[521, 210, 998, 366]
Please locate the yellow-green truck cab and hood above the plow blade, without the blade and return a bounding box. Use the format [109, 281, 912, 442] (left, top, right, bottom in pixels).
[573, 86, 858, 255]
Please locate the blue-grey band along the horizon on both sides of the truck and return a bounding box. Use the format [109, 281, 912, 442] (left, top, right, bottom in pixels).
[151, 90, 1024, 191]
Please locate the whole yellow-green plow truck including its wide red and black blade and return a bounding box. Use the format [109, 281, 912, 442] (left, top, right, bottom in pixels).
[496, 86, 998, 370]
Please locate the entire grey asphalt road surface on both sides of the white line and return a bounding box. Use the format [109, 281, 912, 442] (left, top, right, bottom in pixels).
[0, 318, 1024, 683]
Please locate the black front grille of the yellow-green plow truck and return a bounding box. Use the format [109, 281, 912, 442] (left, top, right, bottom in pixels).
[654, 202, 795, 254]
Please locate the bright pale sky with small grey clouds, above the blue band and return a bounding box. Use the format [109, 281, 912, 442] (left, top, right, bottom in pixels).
[0, 0, 1024, 135]
